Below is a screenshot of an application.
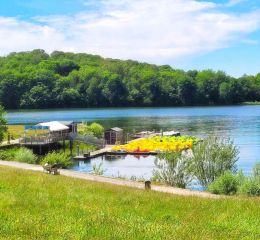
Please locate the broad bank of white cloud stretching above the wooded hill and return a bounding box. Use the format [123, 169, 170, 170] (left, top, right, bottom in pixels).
[0, 0, 260, 63]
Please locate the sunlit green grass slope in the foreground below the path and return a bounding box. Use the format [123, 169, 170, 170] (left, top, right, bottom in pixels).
[0, 167, 260, 240]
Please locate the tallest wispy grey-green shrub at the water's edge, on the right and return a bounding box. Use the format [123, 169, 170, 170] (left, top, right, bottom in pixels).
[192, 136, 239, 187]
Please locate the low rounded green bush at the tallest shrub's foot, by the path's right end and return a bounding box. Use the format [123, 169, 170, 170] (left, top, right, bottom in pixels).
[208, 172, 240, 195]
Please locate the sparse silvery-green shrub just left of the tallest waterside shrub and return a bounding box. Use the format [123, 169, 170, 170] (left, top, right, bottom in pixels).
[153, 151, 192, 188]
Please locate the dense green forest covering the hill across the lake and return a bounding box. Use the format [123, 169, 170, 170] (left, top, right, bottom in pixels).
[0, 50, 260, 109]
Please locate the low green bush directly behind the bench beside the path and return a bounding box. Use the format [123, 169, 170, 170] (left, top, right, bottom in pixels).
[41, 152, 72, 168]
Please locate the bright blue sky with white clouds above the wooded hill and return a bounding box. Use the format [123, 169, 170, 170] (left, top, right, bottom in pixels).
[0, 0, 260, 77]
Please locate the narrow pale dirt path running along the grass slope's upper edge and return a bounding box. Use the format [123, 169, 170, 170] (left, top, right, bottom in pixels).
[0, 160, 220, 198]
